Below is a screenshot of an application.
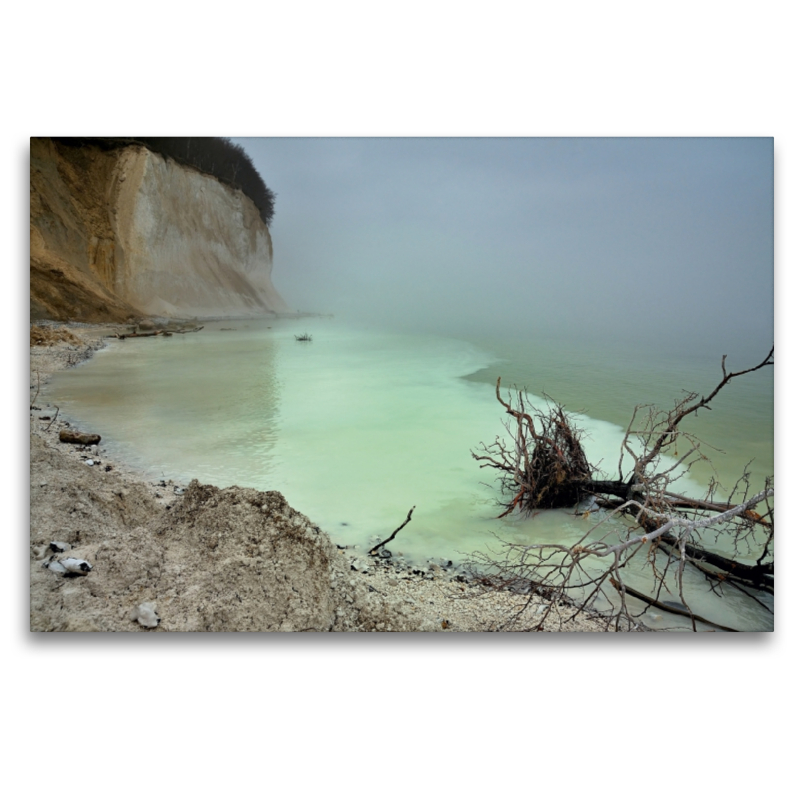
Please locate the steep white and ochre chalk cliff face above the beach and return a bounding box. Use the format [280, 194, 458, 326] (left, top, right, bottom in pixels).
[30, 139, 289, 322]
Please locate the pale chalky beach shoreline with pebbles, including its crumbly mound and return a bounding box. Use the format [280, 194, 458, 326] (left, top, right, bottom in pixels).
[30, 320, 604, 632]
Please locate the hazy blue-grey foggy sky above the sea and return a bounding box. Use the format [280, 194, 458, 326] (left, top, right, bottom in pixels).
[234, 138, 773, 348]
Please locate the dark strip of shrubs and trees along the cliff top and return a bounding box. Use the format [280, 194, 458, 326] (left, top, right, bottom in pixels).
[53, 136, 275, 225]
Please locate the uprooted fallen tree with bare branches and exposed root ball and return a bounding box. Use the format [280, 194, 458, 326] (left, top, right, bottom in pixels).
[472, 348, 774, 630]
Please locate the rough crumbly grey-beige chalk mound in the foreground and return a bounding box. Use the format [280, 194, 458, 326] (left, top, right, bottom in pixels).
[156, 480, 335, 631]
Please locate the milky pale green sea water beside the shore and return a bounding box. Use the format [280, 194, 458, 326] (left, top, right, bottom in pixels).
[45, 319, 773, 630]
